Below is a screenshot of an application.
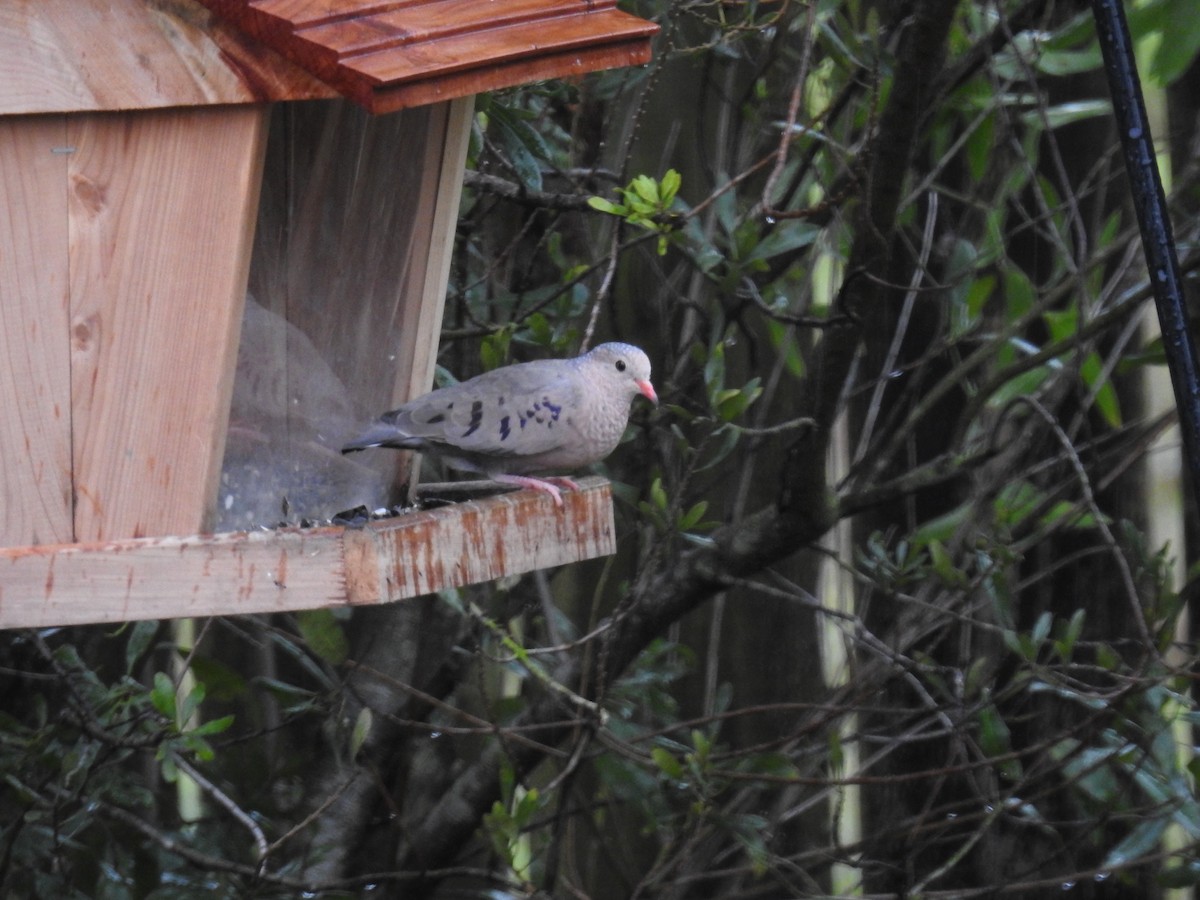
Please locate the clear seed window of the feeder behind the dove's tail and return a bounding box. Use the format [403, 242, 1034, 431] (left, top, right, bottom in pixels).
[217, 100, 449, 530]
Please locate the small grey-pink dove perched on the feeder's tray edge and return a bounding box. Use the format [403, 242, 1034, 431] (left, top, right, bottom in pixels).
[342, 343, 659, 506]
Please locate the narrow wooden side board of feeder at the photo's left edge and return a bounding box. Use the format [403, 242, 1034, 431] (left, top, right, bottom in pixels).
[0, 116, 73, 546]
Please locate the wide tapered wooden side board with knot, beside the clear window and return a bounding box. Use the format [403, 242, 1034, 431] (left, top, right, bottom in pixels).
[68, 107, 265, 541]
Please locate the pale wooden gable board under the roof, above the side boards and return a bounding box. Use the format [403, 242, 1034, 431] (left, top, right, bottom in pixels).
[0, 0, 335, 114]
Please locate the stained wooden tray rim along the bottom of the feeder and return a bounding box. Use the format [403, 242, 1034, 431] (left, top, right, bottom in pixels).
[0, 478, 616, 628]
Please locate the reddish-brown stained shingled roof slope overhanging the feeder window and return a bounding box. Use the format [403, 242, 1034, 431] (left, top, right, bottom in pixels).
[194, 0, 658, 113]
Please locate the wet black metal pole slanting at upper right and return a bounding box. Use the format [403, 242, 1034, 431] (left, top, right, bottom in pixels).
[1092, 0, 1200, 500]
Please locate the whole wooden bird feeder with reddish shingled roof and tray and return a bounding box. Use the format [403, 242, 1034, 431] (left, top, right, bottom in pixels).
[0, 0, 656, 628]
